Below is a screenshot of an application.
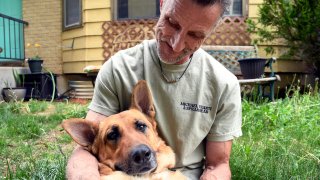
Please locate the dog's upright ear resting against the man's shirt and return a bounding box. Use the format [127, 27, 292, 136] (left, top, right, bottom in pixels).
[131, 80, 155, 118]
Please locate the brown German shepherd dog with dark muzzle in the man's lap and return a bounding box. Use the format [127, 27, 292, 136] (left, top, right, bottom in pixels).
[62, 81, 186, 179]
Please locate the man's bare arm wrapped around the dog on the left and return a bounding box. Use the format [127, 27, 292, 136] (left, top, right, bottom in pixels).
[66, 110, 106, 180]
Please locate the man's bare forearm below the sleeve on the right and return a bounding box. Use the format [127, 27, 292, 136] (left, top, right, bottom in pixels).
[200, 140, 232, 180]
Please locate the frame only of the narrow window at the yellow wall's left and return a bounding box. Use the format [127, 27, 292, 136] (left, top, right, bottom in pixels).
[62, 0, 83, 31]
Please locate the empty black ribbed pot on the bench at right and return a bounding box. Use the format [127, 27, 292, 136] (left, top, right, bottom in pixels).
[238, 58, 267, 79]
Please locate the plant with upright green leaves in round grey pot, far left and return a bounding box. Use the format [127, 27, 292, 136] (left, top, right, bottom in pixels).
[2, 69, 27, 102]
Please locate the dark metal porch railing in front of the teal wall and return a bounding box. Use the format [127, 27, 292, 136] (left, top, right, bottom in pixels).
[0, 13, 28, 62]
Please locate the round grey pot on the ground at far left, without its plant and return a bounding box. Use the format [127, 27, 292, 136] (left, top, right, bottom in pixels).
[2, 87, 27, 102]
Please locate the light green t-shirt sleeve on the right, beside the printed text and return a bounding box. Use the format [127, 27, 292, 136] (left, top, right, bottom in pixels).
[207, 80, 242, 141]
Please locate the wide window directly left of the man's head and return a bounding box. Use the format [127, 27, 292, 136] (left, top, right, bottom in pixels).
[114, 0, 160, 19]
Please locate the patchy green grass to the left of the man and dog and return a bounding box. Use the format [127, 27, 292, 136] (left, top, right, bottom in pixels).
[0, 100, 87, 179]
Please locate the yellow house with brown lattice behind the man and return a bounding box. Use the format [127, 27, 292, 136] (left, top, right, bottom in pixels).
[0, 0, 310, 100]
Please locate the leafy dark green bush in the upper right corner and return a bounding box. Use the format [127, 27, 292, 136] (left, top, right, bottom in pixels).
[247, 0, 320, 75]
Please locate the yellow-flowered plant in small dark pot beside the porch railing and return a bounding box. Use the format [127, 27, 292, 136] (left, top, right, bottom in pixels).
[26, 43, 43, 73]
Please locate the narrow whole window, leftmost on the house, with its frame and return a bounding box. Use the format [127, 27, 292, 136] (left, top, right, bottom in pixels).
[63, 0, 82, 29]
